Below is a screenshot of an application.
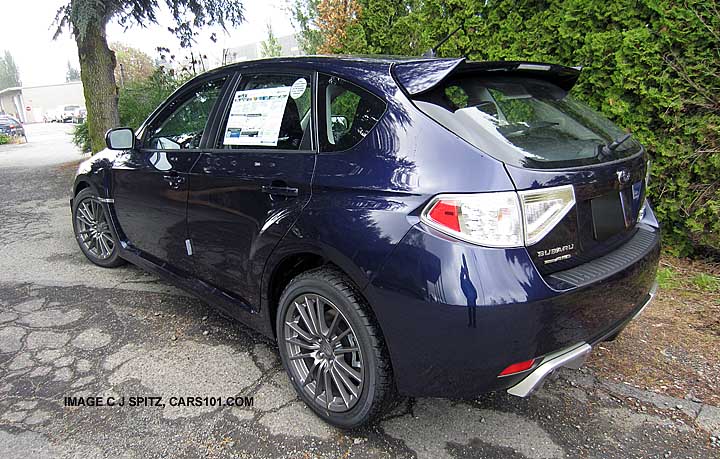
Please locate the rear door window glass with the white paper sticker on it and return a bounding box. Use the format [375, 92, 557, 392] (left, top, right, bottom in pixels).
[217, 74, 312, 150]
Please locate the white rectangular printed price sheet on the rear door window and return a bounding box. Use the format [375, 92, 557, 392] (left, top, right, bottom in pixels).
[223, 86, 290, 146]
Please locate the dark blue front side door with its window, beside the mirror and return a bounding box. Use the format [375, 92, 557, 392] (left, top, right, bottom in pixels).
[112, 74, 226, 271]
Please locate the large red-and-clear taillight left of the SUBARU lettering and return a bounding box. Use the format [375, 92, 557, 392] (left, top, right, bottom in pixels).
[421, 185, 575, 247]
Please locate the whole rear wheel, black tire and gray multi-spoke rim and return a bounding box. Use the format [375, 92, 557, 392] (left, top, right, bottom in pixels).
[276, 268, 394, 429]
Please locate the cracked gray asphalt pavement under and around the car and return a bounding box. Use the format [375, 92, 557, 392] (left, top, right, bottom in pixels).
[0, 125, 720, 458]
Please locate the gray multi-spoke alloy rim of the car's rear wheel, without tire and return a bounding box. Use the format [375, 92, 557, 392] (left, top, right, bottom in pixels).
[284, 294, 365, 412]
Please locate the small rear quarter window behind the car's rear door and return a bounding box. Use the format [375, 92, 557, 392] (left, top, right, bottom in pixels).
[320, 75, 386, 151]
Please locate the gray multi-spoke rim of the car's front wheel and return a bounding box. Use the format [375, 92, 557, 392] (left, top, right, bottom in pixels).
[75, 198, 115, 260]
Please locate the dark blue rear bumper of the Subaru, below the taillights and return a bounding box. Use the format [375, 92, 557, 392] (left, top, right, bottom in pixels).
[365, 223, 660, 398]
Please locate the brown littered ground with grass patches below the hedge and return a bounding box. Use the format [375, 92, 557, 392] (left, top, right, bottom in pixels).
[588, 257, 720, 406]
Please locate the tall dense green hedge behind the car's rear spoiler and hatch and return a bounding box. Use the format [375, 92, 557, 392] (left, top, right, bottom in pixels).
[336, 0, 720, 255]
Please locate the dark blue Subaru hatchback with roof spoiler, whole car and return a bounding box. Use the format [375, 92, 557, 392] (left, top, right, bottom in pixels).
[71, 57, 660, 428]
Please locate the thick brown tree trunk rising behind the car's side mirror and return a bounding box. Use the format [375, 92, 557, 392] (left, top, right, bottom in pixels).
[75, 22, 120, 153]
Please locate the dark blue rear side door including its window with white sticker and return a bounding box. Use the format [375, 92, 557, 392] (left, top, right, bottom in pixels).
[188, 71, 317, 307]
